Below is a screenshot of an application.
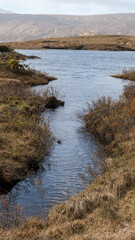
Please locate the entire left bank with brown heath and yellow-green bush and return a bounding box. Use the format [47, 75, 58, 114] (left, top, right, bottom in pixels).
[0, 46, 64, 189]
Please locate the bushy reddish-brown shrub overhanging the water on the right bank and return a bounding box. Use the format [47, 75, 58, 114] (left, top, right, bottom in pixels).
[84, 86, 135, 154]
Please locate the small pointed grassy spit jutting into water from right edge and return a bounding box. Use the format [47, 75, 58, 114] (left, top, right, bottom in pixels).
[112, 68, 135, 82]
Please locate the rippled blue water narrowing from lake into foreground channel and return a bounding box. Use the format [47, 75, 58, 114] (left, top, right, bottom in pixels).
[7, 50, 135, 216]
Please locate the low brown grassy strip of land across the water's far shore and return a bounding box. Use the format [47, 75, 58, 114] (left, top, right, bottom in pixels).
[1, 35, 135, 51]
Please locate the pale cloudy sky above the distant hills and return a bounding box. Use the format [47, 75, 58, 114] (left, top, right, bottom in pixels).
[0, 0, 135, 15]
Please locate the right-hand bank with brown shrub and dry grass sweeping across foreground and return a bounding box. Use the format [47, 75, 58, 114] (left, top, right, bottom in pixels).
[1, 85, 135, 237]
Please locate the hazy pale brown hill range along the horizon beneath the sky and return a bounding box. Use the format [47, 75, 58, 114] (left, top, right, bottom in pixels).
[0, 13, 135, 42]
